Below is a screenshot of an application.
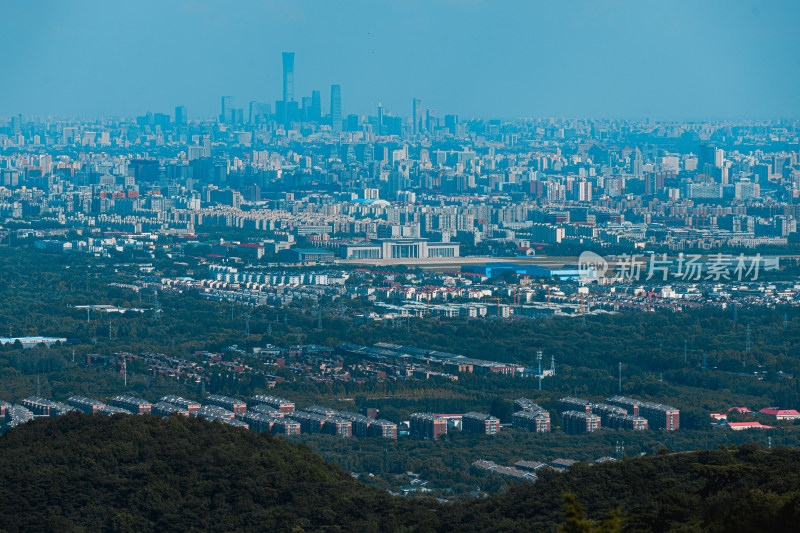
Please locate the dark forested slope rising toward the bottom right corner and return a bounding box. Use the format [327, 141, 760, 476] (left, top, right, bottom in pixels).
[449, 444, 800, 533]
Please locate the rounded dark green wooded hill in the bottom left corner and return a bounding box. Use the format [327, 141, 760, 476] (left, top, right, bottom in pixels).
[0, 414, 437, 532]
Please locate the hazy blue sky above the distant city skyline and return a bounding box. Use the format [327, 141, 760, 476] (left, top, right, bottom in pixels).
[0, 0, 800, 119]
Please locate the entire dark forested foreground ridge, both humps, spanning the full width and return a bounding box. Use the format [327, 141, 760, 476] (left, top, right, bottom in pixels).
[0, 413, 800, 533]
